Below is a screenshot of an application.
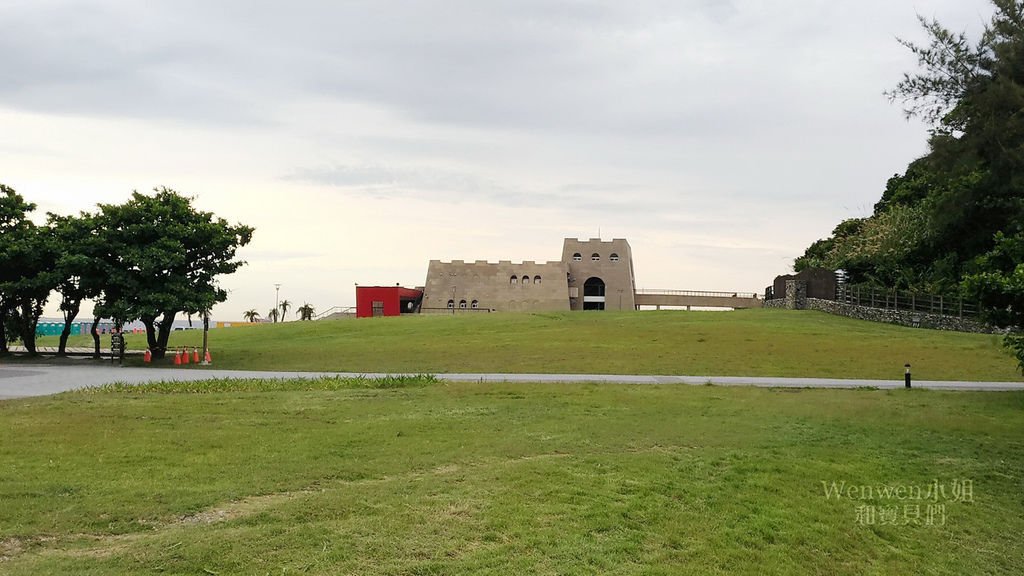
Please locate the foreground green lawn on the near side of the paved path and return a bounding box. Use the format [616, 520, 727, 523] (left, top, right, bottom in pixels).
[0, 379, 1024, 575]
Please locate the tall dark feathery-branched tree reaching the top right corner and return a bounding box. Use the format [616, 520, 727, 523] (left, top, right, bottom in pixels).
[889, 0, 1024, 266]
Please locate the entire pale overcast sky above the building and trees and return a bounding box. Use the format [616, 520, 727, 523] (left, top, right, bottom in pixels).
[0, 0, 991, 320]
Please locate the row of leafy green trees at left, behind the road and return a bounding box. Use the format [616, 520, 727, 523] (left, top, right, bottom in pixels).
[0, 184, 253, 358]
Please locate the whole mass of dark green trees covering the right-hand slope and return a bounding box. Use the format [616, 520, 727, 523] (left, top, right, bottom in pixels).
[795, 0, 1024, 368]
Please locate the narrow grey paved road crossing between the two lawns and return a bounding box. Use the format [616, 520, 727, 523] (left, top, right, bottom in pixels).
[0, 361, 1024, 399]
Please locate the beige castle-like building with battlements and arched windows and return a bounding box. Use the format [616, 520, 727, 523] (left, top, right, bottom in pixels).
[420, 238, 636, 313]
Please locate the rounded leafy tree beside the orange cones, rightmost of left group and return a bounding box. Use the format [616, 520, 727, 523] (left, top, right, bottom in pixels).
[97, 188, 253, 359]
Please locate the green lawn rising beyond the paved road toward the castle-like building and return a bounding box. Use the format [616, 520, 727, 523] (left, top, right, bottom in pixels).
[36, 310, 1022, 381]
